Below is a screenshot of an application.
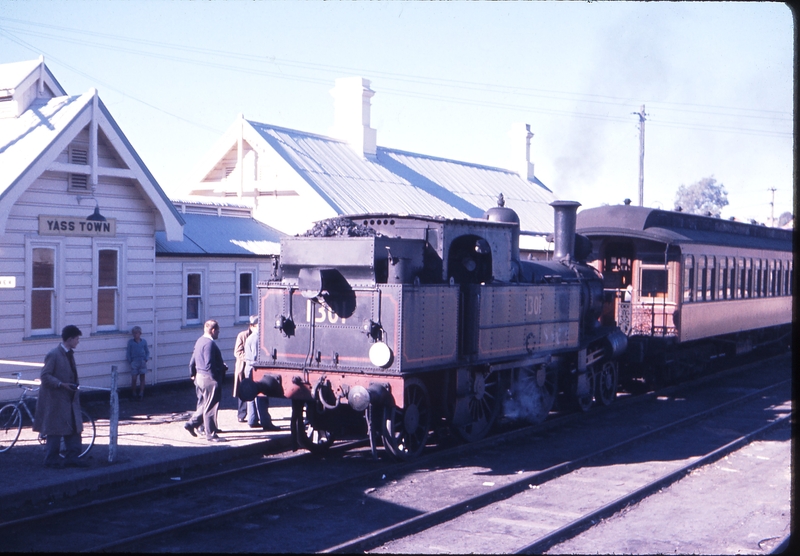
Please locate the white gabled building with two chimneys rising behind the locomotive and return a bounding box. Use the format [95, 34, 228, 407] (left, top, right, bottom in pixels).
[181, 77, 555, 257]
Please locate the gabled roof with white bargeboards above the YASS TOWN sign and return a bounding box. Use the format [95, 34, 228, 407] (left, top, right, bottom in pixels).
[0, 59, 183, 239]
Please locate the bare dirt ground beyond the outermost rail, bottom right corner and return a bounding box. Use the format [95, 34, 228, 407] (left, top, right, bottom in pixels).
[547, 427, 794, 554]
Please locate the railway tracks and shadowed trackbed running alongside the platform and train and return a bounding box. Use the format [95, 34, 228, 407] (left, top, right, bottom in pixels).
[0, 352, 791, 552]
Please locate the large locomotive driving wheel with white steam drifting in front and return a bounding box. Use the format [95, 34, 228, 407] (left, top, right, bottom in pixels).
[506, 365, 558, 424]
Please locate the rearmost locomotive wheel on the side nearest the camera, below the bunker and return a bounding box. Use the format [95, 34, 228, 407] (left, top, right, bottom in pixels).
[382, 378, 431, 460]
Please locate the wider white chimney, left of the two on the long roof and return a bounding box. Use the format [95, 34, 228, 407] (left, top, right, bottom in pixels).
[331, 77, 377, 158]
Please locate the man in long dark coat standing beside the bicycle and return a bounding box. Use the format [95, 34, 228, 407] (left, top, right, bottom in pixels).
[33, 324, 89, 467]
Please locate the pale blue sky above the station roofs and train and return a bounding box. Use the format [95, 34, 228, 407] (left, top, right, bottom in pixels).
[0, 0, 794, 223]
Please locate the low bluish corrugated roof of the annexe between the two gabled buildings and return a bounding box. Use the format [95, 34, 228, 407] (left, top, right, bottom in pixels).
[156, 213, 285, 256]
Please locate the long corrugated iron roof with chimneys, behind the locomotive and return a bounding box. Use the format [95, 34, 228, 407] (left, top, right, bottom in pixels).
[248, 120, 555, 234]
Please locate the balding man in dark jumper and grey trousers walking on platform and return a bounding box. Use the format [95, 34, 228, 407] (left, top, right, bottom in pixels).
[183, 320, 228, 442]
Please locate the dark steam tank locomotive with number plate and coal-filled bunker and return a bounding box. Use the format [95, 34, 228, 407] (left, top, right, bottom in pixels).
[247, 201, 627, 458]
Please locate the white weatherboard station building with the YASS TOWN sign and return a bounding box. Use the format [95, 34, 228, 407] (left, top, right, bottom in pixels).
[0, 58, 282, 400]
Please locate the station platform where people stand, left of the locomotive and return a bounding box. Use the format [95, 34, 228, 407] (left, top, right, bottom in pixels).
[0, 373, 291, 511]
